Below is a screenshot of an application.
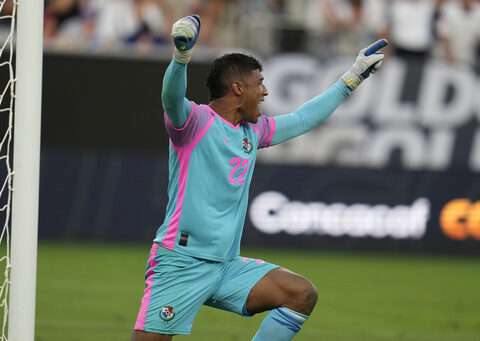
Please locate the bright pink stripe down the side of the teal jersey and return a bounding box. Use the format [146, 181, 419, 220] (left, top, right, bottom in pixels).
[162, 116, 215, 250]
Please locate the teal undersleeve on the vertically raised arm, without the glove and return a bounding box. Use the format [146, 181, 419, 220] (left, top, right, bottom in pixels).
[162, 60, 192, 128]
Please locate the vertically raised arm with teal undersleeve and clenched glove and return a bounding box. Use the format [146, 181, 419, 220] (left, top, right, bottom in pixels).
[162, 14, 201, 128]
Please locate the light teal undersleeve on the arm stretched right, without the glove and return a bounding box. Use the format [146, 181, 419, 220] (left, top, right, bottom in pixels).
[271, 81, 351, 145]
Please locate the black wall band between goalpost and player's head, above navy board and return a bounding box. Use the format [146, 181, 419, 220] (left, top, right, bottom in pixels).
[42, 54, 208, 152]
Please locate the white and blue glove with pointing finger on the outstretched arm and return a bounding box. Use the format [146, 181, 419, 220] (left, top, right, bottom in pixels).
[340, 39, 388, 90]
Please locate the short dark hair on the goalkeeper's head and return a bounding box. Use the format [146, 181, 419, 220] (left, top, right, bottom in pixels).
[206, 53, 262, 100]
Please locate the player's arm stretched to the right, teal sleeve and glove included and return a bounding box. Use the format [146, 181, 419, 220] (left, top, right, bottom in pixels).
[271, 39, 387, 145]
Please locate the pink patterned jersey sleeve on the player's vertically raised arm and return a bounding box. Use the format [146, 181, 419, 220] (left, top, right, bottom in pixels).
[164, 102, 211, 147]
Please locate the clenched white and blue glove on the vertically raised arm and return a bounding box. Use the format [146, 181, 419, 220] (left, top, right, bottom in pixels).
[172, 14, 201, 64]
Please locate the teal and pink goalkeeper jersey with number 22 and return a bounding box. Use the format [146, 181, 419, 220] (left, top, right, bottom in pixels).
[155, 102, 275, 261]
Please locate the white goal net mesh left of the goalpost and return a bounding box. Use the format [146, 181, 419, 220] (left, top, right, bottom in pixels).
[0, 0, 18, 341]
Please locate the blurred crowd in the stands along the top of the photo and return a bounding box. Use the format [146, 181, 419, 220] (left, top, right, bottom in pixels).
[2, 0, 480, 67]
